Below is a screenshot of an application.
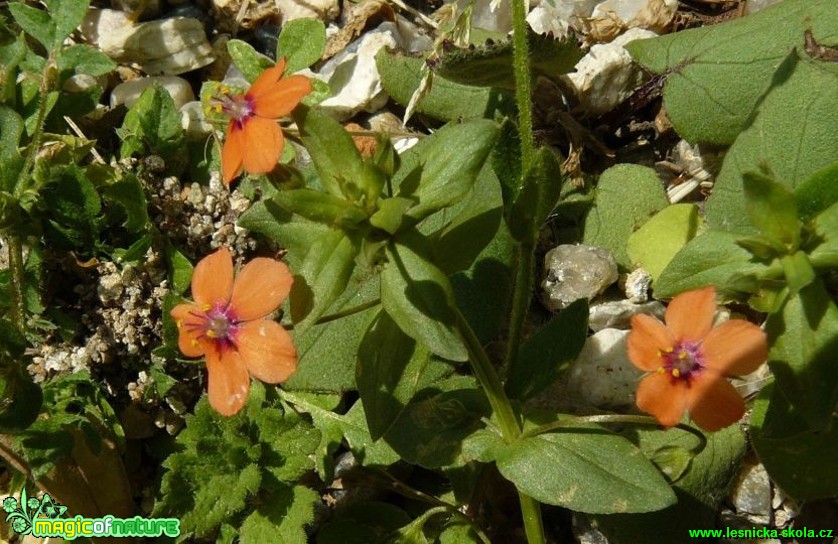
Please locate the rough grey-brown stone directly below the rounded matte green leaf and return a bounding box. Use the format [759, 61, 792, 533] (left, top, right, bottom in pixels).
[541, 244, 617, 311]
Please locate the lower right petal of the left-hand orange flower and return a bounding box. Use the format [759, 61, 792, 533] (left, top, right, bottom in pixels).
[236, 319, 297, 383]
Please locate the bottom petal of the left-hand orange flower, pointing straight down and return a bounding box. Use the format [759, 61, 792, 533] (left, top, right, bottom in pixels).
[207, 349, 250, 416]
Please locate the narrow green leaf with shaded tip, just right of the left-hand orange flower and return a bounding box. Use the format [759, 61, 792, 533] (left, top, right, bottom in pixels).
[290, 229, 358, 331]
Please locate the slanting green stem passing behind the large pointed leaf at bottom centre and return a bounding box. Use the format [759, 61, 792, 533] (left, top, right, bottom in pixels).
[454, 308, 545, 544]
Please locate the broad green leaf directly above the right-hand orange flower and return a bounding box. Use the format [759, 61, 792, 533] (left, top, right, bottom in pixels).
[655, 230, 767, 298]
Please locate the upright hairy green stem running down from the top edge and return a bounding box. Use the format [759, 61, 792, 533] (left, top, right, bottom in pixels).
[512, 0, 535, 172]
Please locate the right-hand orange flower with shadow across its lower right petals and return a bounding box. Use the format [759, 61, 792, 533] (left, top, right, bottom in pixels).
[628, 287, 768, 431]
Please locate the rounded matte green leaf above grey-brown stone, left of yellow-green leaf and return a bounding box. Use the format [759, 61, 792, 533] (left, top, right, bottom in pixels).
[583, 164, 669, 270]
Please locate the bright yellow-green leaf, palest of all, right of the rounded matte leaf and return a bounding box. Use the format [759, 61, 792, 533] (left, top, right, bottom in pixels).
[626, 204, 700, 280]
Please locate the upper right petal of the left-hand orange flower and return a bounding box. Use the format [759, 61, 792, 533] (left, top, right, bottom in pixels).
[230, 257, 294, 321]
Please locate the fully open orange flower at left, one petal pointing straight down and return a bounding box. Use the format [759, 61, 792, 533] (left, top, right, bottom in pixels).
[172, 248, 297, 416]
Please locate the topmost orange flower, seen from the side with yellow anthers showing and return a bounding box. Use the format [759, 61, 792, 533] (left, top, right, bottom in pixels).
[215, 59, 312, 185]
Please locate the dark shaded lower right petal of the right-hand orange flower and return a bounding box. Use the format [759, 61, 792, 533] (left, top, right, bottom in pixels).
[687, 372, 745, 431]
